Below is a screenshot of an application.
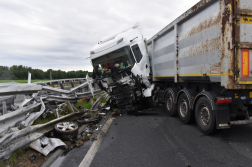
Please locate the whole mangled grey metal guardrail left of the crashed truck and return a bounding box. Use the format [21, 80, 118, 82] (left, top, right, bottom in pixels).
[0, 76, 108, 164]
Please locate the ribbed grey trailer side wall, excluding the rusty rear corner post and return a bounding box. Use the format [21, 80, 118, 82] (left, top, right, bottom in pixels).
[149, 1, 226, 82]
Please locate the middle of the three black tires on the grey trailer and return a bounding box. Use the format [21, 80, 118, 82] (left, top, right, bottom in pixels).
[178, 93, 194, 124]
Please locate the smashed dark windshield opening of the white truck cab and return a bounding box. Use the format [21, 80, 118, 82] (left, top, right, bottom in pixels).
[92, 46, 135, 78]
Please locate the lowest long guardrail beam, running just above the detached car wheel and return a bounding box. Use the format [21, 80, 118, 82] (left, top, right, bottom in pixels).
[0, 109, 83, 161]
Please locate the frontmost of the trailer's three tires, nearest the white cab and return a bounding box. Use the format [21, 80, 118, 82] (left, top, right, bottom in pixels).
[165, 91, 178, 117]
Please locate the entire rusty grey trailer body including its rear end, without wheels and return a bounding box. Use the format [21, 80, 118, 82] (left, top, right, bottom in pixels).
[147, 0, 252, 89]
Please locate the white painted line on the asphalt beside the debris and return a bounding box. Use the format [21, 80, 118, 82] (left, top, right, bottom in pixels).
[79, 118, 113, 167]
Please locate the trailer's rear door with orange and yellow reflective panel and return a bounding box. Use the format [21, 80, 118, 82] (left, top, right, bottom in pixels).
[235, 0, 252, 84]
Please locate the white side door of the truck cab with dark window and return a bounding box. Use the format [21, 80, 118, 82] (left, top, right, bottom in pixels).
[130, 40, 150, 77]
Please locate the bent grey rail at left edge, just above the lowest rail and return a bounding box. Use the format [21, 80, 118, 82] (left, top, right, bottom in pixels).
[0, 102, 41, 137]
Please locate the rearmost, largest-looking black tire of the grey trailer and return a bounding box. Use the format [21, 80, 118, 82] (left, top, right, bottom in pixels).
[195, 97, 216, 134]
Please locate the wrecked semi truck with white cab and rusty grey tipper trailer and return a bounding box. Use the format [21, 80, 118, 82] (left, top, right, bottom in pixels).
[90, 0, 252, 134]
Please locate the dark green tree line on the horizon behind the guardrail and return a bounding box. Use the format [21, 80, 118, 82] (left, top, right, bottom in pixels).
[0, 65, 92, 80]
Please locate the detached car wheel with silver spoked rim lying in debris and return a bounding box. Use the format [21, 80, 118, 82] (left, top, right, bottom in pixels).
[54, 122, 79, 140]
